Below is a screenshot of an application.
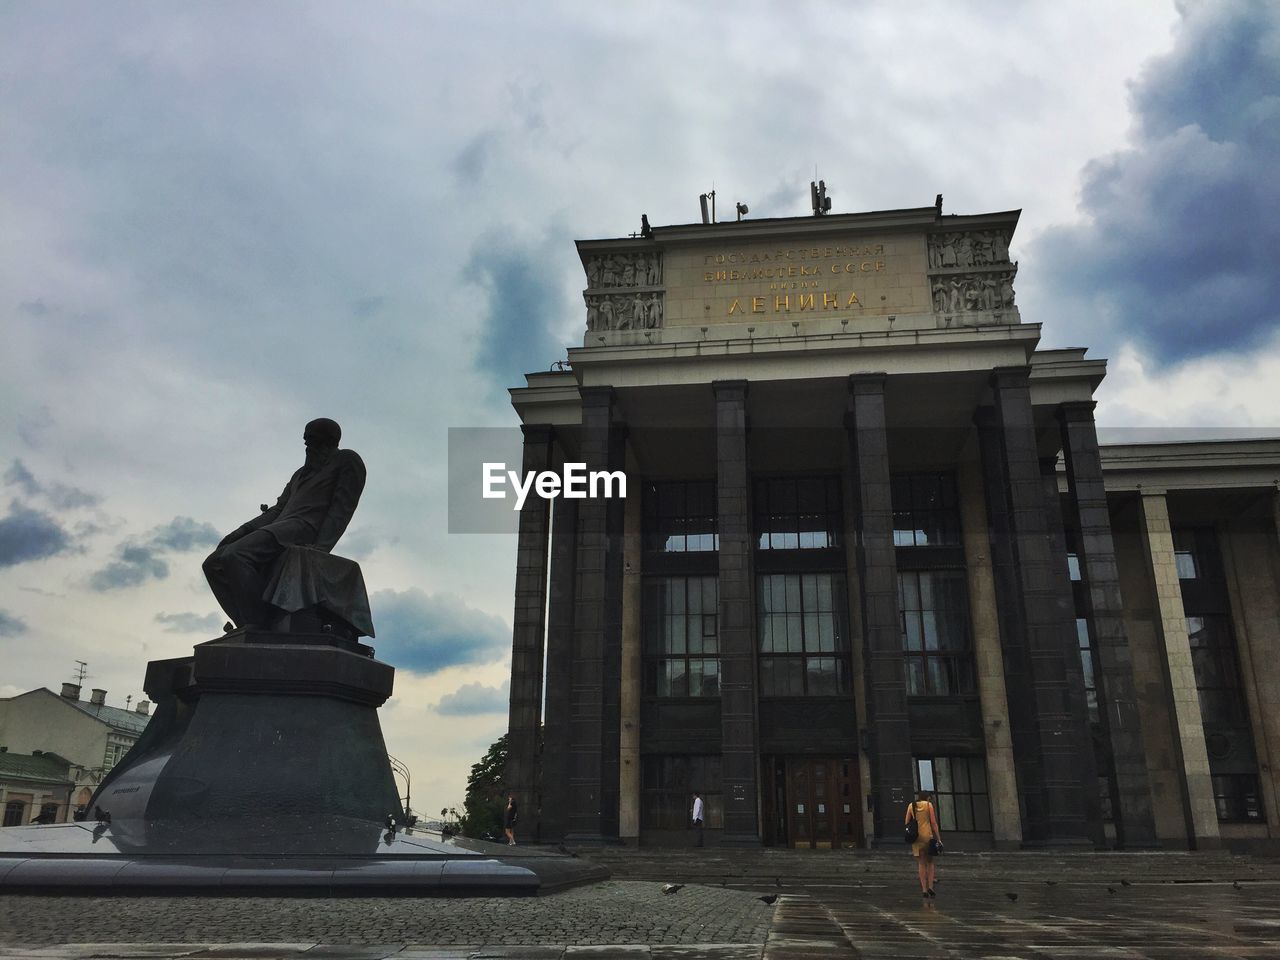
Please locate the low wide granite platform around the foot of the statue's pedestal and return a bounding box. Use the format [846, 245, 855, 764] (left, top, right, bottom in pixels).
[0, 817, 609, 897]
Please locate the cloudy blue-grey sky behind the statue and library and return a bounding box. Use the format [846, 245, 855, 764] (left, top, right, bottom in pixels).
[0, 0, 1280, 810]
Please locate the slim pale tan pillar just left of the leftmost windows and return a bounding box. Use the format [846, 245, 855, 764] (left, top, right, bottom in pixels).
[618, 450, 641, 842]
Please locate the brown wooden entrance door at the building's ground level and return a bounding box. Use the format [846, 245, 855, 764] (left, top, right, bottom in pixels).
[774, 756, 863, 850]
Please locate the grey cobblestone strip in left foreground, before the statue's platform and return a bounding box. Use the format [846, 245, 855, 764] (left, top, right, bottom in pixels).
[0, 881, 773, 959]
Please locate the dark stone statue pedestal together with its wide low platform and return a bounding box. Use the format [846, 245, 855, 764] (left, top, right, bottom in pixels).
[0, 631, 609, 896]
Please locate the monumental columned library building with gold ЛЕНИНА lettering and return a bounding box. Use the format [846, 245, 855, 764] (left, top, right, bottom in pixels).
[507, 204, 1280, 849]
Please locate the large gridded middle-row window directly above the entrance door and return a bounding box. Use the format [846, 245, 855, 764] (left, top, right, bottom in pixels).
[756, 573, 850, 696]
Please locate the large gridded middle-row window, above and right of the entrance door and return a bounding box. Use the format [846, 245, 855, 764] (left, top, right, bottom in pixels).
[897, 570, 977, 696]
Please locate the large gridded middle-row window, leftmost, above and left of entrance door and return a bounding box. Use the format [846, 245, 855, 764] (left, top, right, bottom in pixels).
[641, 576, 719, 696]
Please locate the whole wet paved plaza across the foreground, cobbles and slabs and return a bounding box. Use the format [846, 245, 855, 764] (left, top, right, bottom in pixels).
[0, 849, 1280, 960]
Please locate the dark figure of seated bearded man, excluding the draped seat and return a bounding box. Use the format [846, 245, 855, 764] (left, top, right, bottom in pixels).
[204, 419, 365, 630]
